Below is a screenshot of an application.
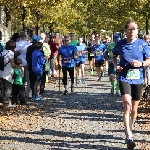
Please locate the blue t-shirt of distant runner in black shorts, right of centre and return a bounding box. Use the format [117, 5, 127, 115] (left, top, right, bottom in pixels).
[92, 43, 106, 60]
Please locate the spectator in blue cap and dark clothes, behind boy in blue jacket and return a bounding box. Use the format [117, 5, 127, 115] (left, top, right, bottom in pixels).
[26, 35, 40, 97]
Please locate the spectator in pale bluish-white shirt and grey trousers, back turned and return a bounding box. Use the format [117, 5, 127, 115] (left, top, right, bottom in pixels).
[15, 31, 31, 97]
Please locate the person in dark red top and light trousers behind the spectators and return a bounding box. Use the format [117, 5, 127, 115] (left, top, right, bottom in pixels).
[48, 35, 59, 77]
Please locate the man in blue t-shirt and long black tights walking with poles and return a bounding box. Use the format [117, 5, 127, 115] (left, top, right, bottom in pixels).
[58, 36, 77, 95]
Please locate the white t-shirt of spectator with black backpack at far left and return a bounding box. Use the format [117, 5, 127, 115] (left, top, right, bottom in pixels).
[0, 50, 14, 83]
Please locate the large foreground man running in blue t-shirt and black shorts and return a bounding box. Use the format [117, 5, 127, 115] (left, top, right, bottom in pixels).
[112, 21, 150, 150]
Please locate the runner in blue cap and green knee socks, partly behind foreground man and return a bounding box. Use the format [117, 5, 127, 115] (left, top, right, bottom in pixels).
[105, 34, 121, 96]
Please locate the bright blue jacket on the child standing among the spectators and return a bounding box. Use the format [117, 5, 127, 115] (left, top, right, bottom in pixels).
[32, 49, 45, 73]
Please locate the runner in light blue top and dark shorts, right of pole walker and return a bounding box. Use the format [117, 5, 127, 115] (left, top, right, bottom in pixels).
[76, 37, 86, 84]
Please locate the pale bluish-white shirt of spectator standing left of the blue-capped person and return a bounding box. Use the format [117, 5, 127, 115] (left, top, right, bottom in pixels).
[15, 40, 31, 66]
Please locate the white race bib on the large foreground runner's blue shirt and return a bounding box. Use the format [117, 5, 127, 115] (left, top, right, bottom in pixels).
[126, 69, 140, 79]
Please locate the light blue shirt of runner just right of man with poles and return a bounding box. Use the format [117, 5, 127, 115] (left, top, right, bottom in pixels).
[76, 43, 86, 63]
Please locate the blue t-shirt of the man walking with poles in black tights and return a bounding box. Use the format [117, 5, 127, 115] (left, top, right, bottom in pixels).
[58, 45, 77, 68]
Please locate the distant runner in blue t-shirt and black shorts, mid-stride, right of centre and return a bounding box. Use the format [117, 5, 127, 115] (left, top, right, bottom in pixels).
[92, 36, 106, 82]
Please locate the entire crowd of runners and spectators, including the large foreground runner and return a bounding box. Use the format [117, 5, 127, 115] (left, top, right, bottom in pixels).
[0, 21, 150, 149]
